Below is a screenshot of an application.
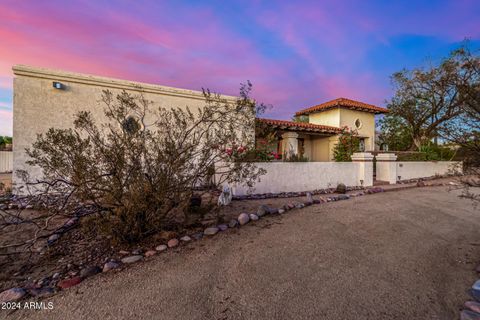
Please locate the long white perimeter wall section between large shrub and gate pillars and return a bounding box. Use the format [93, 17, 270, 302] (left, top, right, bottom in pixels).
[234, 162, 366, 195]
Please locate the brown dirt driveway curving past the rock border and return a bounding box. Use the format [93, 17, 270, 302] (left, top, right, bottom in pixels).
[6, 187, 480, 320]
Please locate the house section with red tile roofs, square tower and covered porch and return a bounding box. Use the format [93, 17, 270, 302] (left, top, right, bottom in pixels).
[257, 98, 388, 161]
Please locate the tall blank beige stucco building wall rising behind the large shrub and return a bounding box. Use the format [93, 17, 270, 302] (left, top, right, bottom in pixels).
[13, 66, 240, 189]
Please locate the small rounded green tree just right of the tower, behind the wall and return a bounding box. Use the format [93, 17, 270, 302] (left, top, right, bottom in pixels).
[377, 114, 413, 151]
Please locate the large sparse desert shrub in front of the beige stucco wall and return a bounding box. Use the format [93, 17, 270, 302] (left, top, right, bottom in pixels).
[20, 84, 263, 242]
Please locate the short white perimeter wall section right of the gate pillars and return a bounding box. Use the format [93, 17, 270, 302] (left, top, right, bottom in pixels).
[394, 161, 462, 180]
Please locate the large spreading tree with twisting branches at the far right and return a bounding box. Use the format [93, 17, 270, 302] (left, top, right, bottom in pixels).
[388, 44, 478, 149]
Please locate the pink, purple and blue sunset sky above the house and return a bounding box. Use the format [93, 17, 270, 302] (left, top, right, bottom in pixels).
[0, 0, 480, 135]
